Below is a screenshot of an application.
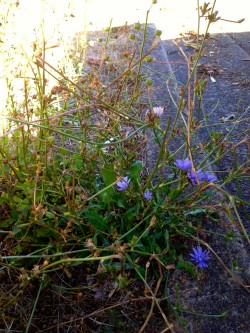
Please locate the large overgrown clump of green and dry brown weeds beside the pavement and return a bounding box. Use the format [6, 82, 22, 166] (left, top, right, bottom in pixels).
[0, 2, 249, 332]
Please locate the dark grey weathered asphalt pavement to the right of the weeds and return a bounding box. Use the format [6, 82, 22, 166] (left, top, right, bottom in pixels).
[143, 25, 250, 333]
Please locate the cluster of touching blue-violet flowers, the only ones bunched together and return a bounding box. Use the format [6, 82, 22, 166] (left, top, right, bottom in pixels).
[174, 157, 218, 185]
